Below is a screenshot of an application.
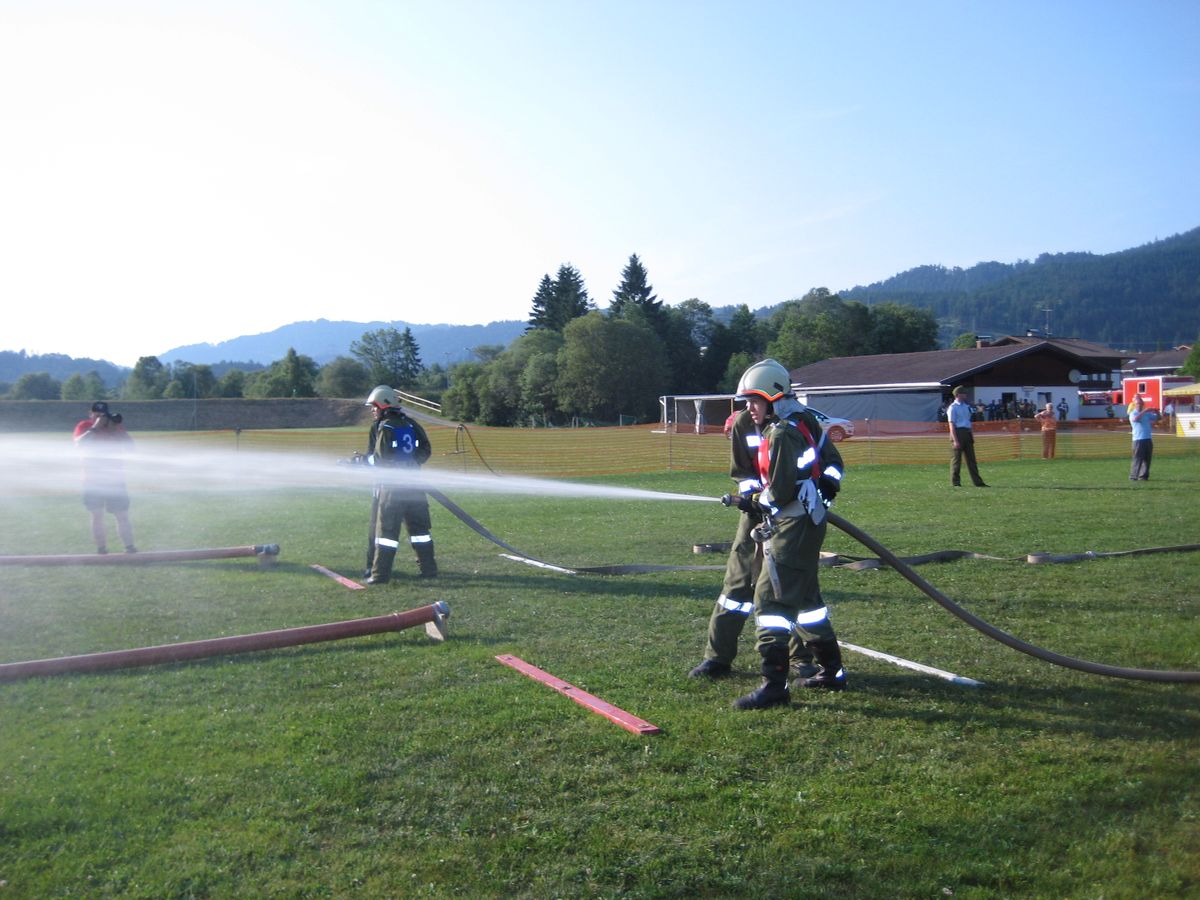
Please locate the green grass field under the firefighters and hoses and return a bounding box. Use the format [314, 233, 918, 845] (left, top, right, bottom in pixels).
[0, 446, 1200, 898]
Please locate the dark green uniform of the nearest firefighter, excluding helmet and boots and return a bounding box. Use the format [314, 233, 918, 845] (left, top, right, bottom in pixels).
[754, 398, 844, 680]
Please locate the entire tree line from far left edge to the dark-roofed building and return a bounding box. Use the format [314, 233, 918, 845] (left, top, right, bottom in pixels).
[0, 253, 937, 426]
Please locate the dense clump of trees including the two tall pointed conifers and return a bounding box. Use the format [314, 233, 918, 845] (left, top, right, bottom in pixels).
[443, 254, 937, 425]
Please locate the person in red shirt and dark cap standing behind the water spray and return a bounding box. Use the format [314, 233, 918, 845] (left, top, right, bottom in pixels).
[73, 400, 138, 553]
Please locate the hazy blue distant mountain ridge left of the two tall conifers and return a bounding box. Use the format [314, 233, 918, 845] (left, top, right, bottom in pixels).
[158, 319, 527, 366]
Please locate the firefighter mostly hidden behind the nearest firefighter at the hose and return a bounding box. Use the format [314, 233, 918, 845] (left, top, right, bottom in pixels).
[689, 409, 817, 678]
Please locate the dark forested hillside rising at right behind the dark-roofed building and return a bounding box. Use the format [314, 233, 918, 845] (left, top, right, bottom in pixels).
[840, 228, 1200, 349]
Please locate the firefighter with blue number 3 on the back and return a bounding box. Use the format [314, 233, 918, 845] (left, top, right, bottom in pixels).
[366, 384, 438, 584]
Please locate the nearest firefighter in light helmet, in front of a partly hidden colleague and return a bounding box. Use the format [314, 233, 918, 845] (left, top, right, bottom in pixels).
[734, 359, 846, 709]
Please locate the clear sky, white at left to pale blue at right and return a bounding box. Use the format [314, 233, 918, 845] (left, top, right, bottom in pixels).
[0, 0, 1200, 365]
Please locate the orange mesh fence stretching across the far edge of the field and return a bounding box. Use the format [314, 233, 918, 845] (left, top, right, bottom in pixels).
[139, 422, 1200, 478]
